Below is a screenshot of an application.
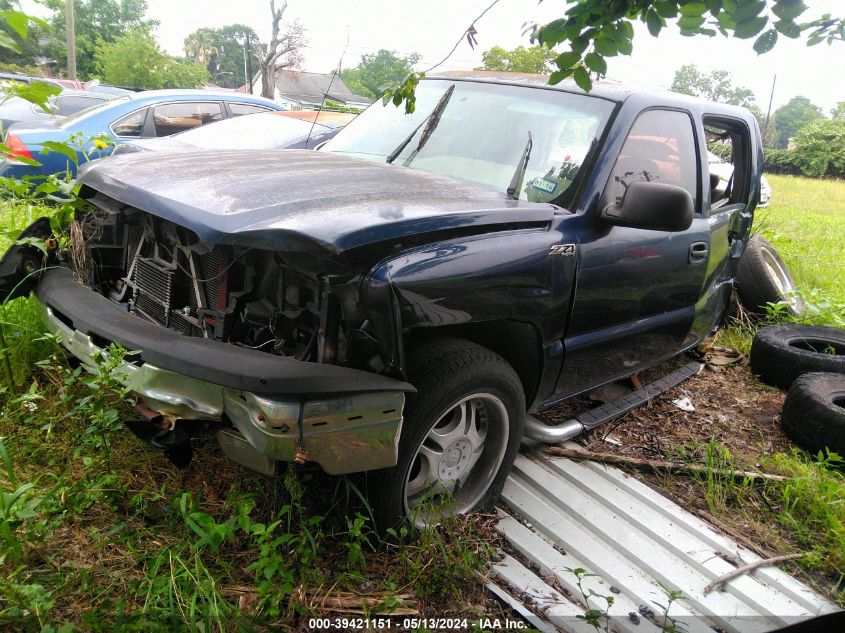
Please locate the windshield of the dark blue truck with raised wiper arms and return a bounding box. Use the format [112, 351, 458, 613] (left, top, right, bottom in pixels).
[324, 81, 612, 202]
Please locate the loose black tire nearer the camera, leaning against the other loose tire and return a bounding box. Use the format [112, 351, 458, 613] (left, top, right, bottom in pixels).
[781, 373, 845, 455]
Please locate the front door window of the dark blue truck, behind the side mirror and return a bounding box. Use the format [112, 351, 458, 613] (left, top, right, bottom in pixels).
[604, 110, 698, 205]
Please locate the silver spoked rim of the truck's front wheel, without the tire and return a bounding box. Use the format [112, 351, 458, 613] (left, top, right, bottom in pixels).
[404, 393, 509, 528]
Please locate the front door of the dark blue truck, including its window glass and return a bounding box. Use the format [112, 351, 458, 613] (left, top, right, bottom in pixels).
[556, 109, 710, 397]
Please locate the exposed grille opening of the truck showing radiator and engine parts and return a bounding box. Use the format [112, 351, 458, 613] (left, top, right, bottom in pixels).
[73, 200, 320, 359]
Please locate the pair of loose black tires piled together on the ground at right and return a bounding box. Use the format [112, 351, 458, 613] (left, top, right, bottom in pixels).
[751, 325, 845, 455]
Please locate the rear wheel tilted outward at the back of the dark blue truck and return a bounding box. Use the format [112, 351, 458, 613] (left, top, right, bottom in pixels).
[736, 234, 803, 315]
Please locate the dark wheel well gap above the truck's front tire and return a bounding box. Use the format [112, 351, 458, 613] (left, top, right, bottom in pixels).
[404, 321, 542, 402]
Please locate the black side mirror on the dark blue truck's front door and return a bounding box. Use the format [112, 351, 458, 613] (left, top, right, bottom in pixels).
[601, 182, 693, 231]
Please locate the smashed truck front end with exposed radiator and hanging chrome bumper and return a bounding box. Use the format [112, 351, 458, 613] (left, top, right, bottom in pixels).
[3, 194, 413, 474]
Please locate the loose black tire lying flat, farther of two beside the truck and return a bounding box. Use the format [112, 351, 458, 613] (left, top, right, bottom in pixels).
[751, 325, 845, 389]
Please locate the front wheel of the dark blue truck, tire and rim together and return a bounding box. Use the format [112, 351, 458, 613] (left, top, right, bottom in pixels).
[368, 339, 525, 529]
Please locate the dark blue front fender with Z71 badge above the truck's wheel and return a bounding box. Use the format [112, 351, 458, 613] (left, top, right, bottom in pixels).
[361, 221, 577, 386]
